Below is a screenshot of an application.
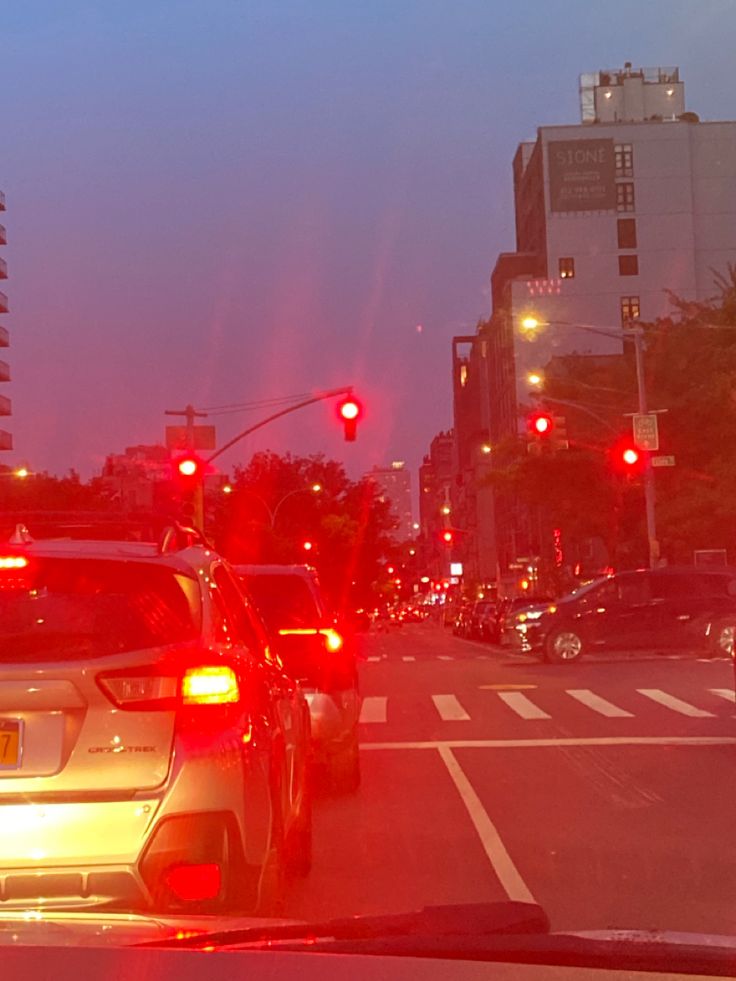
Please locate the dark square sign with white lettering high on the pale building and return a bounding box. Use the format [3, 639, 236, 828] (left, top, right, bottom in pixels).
[547, 139, 616, 212]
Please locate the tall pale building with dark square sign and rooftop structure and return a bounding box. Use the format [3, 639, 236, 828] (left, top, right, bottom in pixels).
[491, 65, 736, 402]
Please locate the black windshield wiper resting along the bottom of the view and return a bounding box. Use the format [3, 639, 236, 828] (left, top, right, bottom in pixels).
[141, 901, 550, 948]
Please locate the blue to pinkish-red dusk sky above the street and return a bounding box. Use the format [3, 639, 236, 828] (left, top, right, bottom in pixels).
[0, 0, 736, 494]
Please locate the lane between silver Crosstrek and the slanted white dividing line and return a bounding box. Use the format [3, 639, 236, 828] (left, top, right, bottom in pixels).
[286, 750, 506, 920]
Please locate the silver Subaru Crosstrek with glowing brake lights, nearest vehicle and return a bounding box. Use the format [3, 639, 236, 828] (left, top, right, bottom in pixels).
[0, 529, 311, 912]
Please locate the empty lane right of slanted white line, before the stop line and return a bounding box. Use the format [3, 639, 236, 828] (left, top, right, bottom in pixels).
[452, 745, 736, 934]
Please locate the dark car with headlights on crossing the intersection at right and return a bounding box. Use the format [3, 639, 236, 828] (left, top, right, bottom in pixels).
[505, 566, 736, 662]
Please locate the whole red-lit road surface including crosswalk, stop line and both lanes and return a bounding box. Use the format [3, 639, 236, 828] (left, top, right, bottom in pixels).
[287, 623, 736, 934]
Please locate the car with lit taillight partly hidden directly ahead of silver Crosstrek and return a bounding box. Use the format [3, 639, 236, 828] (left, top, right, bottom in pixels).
[235, 565, 360, 791]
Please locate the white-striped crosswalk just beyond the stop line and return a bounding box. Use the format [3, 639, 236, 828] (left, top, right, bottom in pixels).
[360, 688, 736, 725]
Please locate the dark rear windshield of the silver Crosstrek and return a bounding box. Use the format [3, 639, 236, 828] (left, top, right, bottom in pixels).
[0, 558, 201, 664]
